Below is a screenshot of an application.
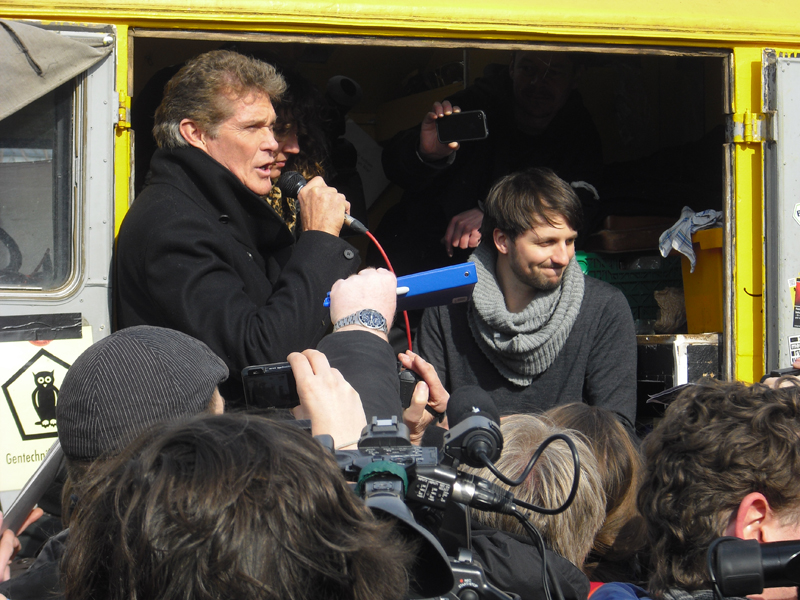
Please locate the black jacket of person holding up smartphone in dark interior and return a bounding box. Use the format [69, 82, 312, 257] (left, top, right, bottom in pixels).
[368, 69, 603, 275]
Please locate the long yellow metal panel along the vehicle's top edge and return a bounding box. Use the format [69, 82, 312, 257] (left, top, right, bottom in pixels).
[0, 0, 800, 44]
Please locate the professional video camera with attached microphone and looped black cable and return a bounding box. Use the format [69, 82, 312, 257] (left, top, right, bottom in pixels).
[335, 414, 580, 600]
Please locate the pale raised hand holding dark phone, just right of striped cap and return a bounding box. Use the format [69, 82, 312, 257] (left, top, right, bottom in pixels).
[287, 350, 367, 448]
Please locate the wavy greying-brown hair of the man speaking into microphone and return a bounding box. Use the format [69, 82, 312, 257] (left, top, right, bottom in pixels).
[153, 50, 286, 148]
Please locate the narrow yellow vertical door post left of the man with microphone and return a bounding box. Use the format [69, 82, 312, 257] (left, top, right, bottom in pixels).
[114, 25, 131, 234]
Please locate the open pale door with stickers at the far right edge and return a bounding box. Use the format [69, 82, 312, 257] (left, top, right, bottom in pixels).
[762, 49, 800, 372]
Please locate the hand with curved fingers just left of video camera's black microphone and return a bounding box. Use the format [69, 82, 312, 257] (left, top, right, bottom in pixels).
[397, 350, 450, 446]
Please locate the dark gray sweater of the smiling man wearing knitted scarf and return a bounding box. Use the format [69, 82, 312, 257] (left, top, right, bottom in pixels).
[416, 277, 636, 430]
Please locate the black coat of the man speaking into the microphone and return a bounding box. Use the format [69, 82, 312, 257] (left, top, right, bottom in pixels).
[115, 147, 359, 402]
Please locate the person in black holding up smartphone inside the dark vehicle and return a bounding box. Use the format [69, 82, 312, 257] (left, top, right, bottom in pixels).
[370, 51, 602, 275]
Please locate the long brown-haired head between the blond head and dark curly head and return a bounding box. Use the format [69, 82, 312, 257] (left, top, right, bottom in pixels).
[545, 402, 644, 577]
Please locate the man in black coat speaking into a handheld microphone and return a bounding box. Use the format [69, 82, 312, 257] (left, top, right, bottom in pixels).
[115, 50, 360, 405]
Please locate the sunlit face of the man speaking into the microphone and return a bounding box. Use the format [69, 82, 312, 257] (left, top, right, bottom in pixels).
[201, 92, 278, 196]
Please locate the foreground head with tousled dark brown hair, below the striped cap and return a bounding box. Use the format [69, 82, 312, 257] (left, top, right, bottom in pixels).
[63, 413, 413, 600]
